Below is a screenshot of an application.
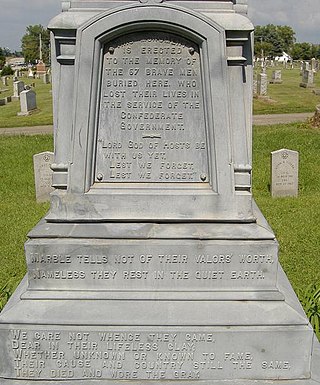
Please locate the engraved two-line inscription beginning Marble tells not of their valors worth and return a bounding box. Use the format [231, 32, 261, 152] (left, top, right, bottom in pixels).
[26, 240, 278, 292]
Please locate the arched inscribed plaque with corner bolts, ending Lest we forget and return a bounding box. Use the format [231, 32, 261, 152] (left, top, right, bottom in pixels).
[95, 32, 208, 183]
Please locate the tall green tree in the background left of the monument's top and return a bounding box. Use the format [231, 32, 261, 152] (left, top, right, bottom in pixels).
[21, 24, 50, 64]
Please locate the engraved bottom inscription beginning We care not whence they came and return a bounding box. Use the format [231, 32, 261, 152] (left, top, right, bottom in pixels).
[1, 327, 308, 380]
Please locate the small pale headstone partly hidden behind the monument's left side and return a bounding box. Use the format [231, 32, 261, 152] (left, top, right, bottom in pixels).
[33, 151, 54, 202]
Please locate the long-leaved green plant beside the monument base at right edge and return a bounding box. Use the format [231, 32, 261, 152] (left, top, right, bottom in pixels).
[298, 283, 320, 341]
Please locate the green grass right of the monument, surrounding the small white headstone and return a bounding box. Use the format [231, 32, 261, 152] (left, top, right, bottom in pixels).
[253, 124, 320, 292]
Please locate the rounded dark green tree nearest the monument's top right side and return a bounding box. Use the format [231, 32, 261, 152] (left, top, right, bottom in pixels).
[254, 24, 295, 58]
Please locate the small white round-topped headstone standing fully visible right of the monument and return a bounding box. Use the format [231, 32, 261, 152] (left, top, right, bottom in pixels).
[271, 149, 299, 197]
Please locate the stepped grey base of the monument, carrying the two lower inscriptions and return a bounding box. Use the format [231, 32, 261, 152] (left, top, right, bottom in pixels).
[0, 207, 320, 385]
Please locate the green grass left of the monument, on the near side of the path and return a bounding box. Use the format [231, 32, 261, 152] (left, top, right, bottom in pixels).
[0, 135, 53, 288]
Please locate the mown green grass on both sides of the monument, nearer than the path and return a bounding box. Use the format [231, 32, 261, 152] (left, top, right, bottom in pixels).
[0, 124, 320, 302]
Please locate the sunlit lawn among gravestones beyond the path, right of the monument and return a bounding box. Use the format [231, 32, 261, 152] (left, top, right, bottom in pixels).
[253, 67, 320, 115]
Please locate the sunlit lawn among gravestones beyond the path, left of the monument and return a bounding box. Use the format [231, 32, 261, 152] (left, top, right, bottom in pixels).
[0, 77, 53, 128]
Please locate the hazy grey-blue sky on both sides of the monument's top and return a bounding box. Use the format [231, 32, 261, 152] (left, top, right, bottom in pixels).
[0, 0, 320, 50]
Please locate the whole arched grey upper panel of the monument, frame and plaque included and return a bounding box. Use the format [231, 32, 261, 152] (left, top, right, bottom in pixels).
[54, 4, 252, 221]
